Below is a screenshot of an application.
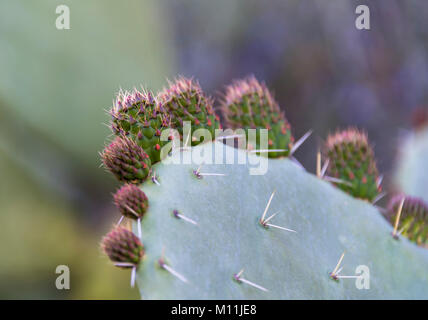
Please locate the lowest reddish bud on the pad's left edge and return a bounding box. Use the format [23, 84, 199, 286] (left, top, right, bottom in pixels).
[101, 227, 144, 268]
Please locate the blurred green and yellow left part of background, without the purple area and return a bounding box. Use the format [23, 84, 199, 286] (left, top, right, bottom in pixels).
[0, 0, 172, 298]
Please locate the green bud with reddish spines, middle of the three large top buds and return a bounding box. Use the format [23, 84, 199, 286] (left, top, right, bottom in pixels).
[158, 77, 220, 146]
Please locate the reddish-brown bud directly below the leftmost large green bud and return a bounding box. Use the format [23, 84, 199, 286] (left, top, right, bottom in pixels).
[101, 137, 151, 184]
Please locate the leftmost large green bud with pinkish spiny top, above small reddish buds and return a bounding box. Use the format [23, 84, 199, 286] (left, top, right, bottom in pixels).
[110, 90, 170, 164]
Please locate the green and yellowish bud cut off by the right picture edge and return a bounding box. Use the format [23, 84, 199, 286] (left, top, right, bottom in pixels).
[388, 194, 428, 245]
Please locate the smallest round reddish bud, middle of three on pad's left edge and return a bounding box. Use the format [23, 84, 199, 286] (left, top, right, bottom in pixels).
[113, 184, 149, 220]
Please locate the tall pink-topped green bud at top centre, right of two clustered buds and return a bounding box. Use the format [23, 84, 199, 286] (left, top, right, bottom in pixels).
[222, 76, 294, 158]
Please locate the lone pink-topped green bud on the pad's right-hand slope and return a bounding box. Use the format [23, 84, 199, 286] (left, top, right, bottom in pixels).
[324, 128, 381, 201]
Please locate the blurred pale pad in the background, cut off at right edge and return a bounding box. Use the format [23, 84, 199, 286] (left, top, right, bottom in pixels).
[395, 127, 428, 201]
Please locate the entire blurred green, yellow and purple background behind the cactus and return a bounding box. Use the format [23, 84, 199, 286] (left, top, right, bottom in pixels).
[0, 0, 428, 299]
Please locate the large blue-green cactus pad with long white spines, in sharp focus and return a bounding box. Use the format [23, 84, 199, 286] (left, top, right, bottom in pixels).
[128, 142, 428, 299]
